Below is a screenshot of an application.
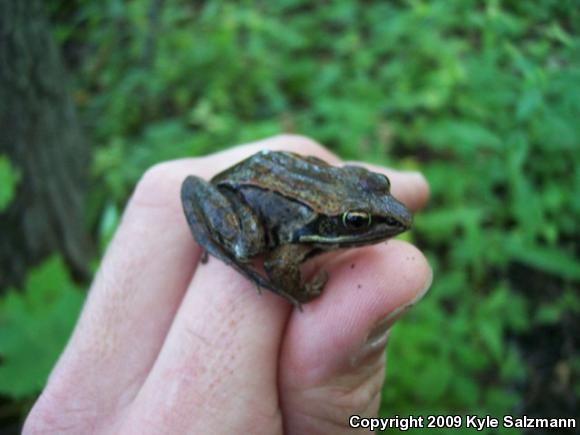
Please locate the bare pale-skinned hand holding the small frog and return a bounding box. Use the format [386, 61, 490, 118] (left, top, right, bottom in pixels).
[23, 136, 432, 435]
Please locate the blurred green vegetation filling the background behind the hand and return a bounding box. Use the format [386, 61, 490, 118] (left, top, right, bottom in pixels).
[0, 0, 580, 433]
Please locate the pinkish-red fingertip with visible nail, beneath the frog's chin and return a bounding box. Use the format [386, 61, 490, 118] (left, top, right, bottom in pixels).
[279, 240, 432, 434]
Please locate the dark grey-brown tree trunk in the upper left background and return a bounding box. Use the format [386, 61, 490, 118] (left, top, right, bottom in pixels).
[0, 0, 89, 288]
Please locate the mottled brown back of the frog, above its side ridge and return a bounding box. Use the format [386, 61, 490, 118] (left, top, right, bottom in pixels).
[212, 151, 386, 215]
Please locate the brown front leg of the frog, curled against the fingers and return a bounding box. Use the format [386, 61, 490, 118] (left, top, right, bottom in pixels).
[264, 244, 328, 308]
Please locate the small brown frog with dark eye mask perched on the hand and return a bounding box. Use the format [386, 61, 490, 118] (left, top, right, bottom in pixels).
[181, 150, 413, 311]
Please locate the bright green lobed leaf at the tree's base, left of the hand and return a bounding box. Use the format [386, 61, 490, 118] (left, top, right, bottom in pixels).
[0, 257, 84, 398]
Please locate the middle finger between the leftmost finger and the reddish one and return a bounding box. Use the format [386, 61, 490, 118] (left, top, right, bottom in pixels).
[121, 258, 291, 434]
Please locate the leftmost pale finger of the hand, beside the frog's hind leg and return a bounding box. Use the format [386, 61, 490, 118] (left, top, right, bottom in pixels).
[28, 159, 206, 433]
